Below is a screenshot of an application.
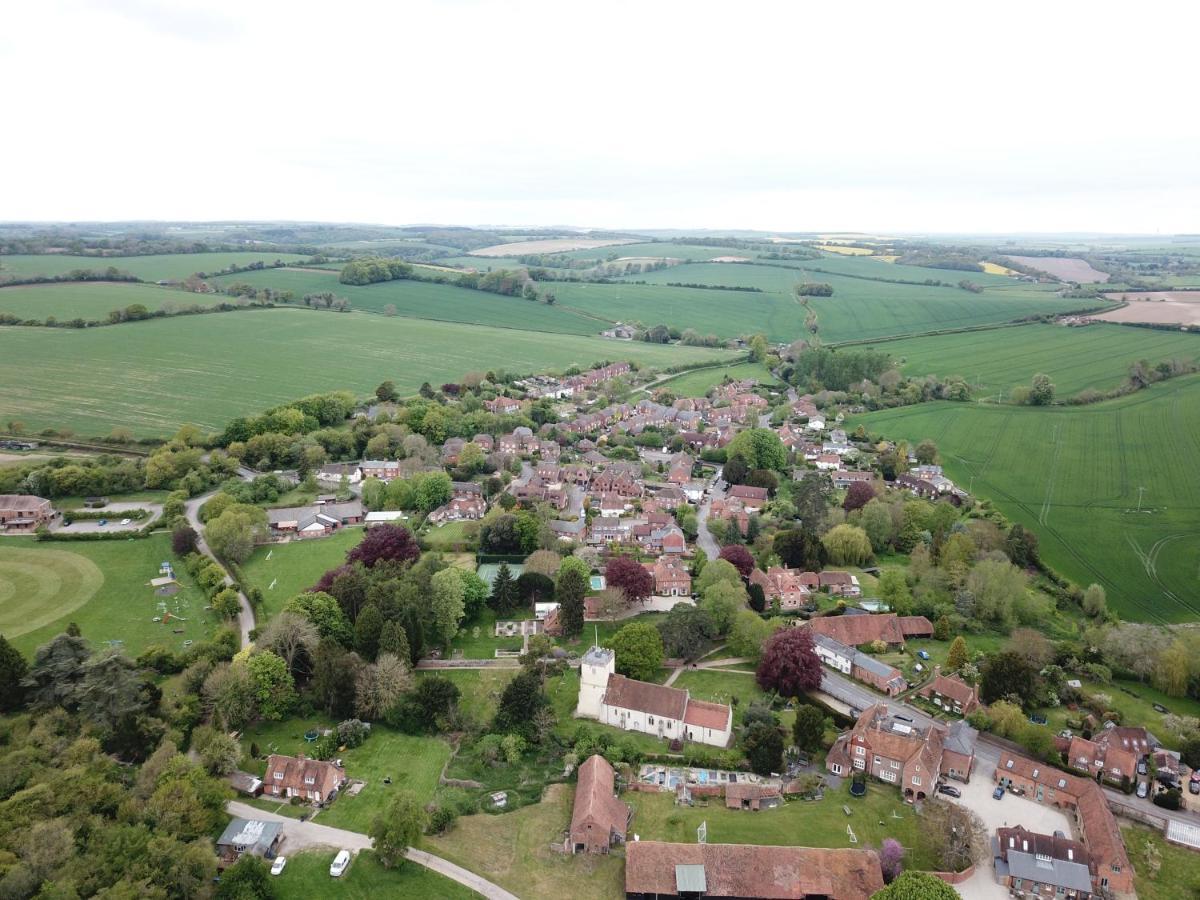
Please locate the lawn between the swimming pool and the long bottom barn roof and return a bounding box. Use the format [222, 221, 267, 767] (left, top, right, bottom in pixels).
[622, 781, 936, 869]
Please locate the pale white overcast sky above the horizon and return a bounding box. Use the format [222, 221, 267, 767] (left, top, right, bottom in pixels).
[0, 0, 1200, 233]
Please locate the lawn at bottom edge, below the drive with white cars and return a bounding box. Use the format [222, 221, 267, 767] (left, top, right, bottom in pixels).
[271, 850, 479, 900]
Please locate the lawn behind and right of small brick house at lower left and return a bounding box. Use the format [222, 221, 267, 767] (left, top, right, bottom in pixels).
[241, 716, 450, 833]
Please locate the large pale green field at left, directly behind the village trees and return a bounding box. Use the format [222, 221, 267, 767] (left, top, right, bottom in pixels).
[0, 309, 732, 437]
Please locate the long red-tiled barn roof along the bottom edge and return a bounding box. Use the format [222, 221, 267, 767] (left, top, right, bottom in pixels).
[625, 841, 883, 900]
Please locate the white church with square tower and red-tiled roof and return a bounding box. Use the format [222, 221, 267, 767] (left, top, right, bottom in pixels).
[575, 647, 733, 746]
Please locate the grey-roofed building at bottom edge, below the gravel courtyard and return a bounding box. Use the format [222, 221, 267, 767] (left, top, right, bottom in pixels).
[992, 826, 1094, 900]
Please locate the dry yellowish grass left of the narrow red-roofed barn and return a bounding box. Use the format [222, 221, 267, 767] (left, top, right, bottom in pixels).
[427, 785, 625, 900]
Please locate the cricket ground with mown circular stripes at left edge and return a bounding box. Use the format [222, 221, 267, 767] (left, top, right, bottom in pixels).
[0, 534, 217, 656]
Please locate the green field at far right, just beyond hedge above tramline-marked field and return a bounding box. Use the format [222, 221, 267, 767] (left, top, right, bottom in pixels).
[876, 325, 1200, 397]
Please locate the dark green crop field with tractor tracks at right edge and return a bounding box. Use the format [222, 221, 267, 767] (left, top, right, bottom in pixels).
[853, 376, 1200, 622]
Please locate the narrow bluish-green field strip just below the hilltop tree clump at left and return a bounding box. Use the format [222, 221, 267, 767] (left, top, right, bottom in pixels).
[206, 269, 608, 335]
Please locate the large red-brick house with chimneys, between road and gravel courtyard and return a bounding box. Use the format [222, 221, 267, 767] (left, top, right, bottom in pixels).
[826, 703, 977, 800]
